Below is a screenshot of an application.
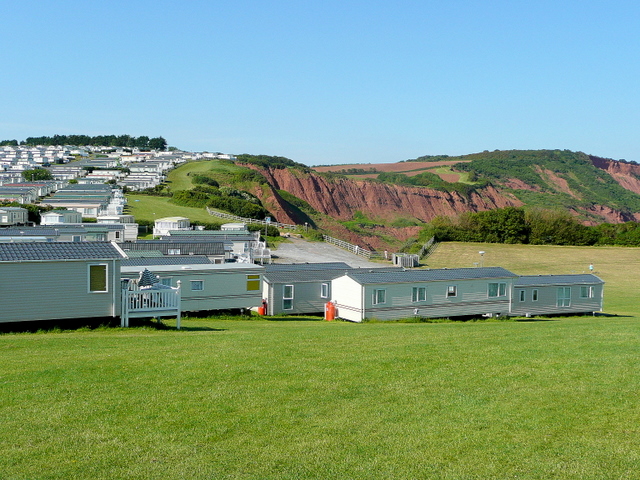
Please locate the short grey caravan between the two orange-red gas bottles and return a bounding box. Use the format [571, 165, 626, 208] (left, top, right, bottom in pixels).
[262, 262, 352, 315]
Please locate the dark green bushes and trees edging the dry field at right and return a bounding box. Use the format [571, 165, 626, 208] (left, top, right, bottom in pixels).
[421, 207, 640, 246]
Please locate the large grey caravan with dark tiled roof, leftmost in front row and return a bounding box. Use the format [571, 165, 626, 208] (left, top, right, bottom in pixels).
[0, 242, 125, 322]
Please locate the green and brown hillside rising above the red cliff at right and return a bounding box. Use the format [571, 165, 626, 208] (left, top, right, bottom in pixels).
[316, 150, 640, 221]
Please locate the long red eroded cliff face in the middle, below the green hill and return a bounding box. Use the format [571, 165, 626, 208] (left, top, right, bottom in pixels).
[262, 169, 522, 222]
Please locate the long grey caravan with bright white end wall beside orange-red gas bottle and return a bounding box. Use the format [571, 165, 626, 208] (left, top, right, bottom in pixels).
[332, 267, 518, 322]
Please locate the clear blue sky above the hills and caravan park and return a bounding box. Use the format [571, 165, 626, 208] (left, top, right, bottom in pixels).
[0, 0, 640, 165]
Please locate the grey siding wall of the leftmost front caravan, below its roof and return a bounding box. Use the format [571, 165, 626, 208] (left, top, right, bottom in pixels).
[0, 260, 120, 322]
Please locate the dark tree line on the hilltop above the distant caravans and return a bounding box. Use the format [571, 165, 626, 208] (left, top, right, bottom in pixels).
[0, 135, 167, 150]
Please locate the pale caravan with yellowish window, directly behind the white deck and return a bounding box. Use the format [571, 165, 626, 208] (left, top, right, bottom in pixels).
[122, 263, 264, 312]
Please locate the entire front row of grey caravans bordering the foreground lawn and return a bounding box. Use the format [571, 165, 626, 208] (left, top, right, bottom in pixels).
[0, 242, 604, 325]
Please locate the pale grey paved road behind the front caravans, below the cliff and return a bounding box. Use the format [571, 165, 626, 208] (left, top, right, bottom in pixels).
[272, 238, 383, 268]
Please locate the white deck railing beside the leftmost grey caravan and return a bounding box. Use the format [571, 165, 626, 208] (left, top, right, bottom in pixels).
[120, 281, 181, 329]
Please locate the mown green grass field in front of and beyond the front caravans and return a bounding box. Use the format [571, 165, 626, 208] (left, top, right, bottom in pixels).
[0, 244, 640, 480]
